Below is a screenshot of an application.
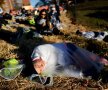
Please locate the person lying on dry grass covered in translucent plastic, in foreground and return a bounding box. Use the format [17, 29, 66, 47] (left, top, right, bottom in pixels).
[31, 42, 108, 79]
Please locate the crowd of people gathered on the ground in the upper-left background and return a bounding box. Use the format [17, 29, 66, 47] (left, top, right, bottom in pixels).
[0, 4, 62, 37]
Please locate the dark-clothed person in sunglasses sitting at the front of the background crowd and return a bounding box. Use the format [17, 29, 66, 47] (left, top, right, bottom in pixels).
[35, 9, 52, 34]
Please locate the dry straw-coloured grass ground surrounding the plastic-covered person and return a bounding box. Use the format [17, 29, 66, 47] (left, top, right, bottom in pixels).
[0, 8, 108, 90]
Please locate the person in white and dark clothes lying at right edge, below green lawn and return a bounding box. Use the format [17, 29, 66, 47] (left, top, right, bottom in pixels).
[76, 30, 108, 41]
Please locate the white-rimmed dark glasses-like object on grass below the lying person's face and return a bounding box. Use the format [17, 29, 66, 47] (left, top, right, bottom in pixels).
[30, 74, 53, 86]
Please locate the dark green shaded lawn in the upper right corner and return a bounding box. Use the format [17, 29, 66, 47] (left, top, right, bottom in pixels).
[71, 0, 108, 29]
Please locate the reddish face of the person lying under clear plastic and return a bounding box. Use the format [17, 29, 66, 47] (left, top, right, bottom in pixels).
[33, 58, 45, 74]
